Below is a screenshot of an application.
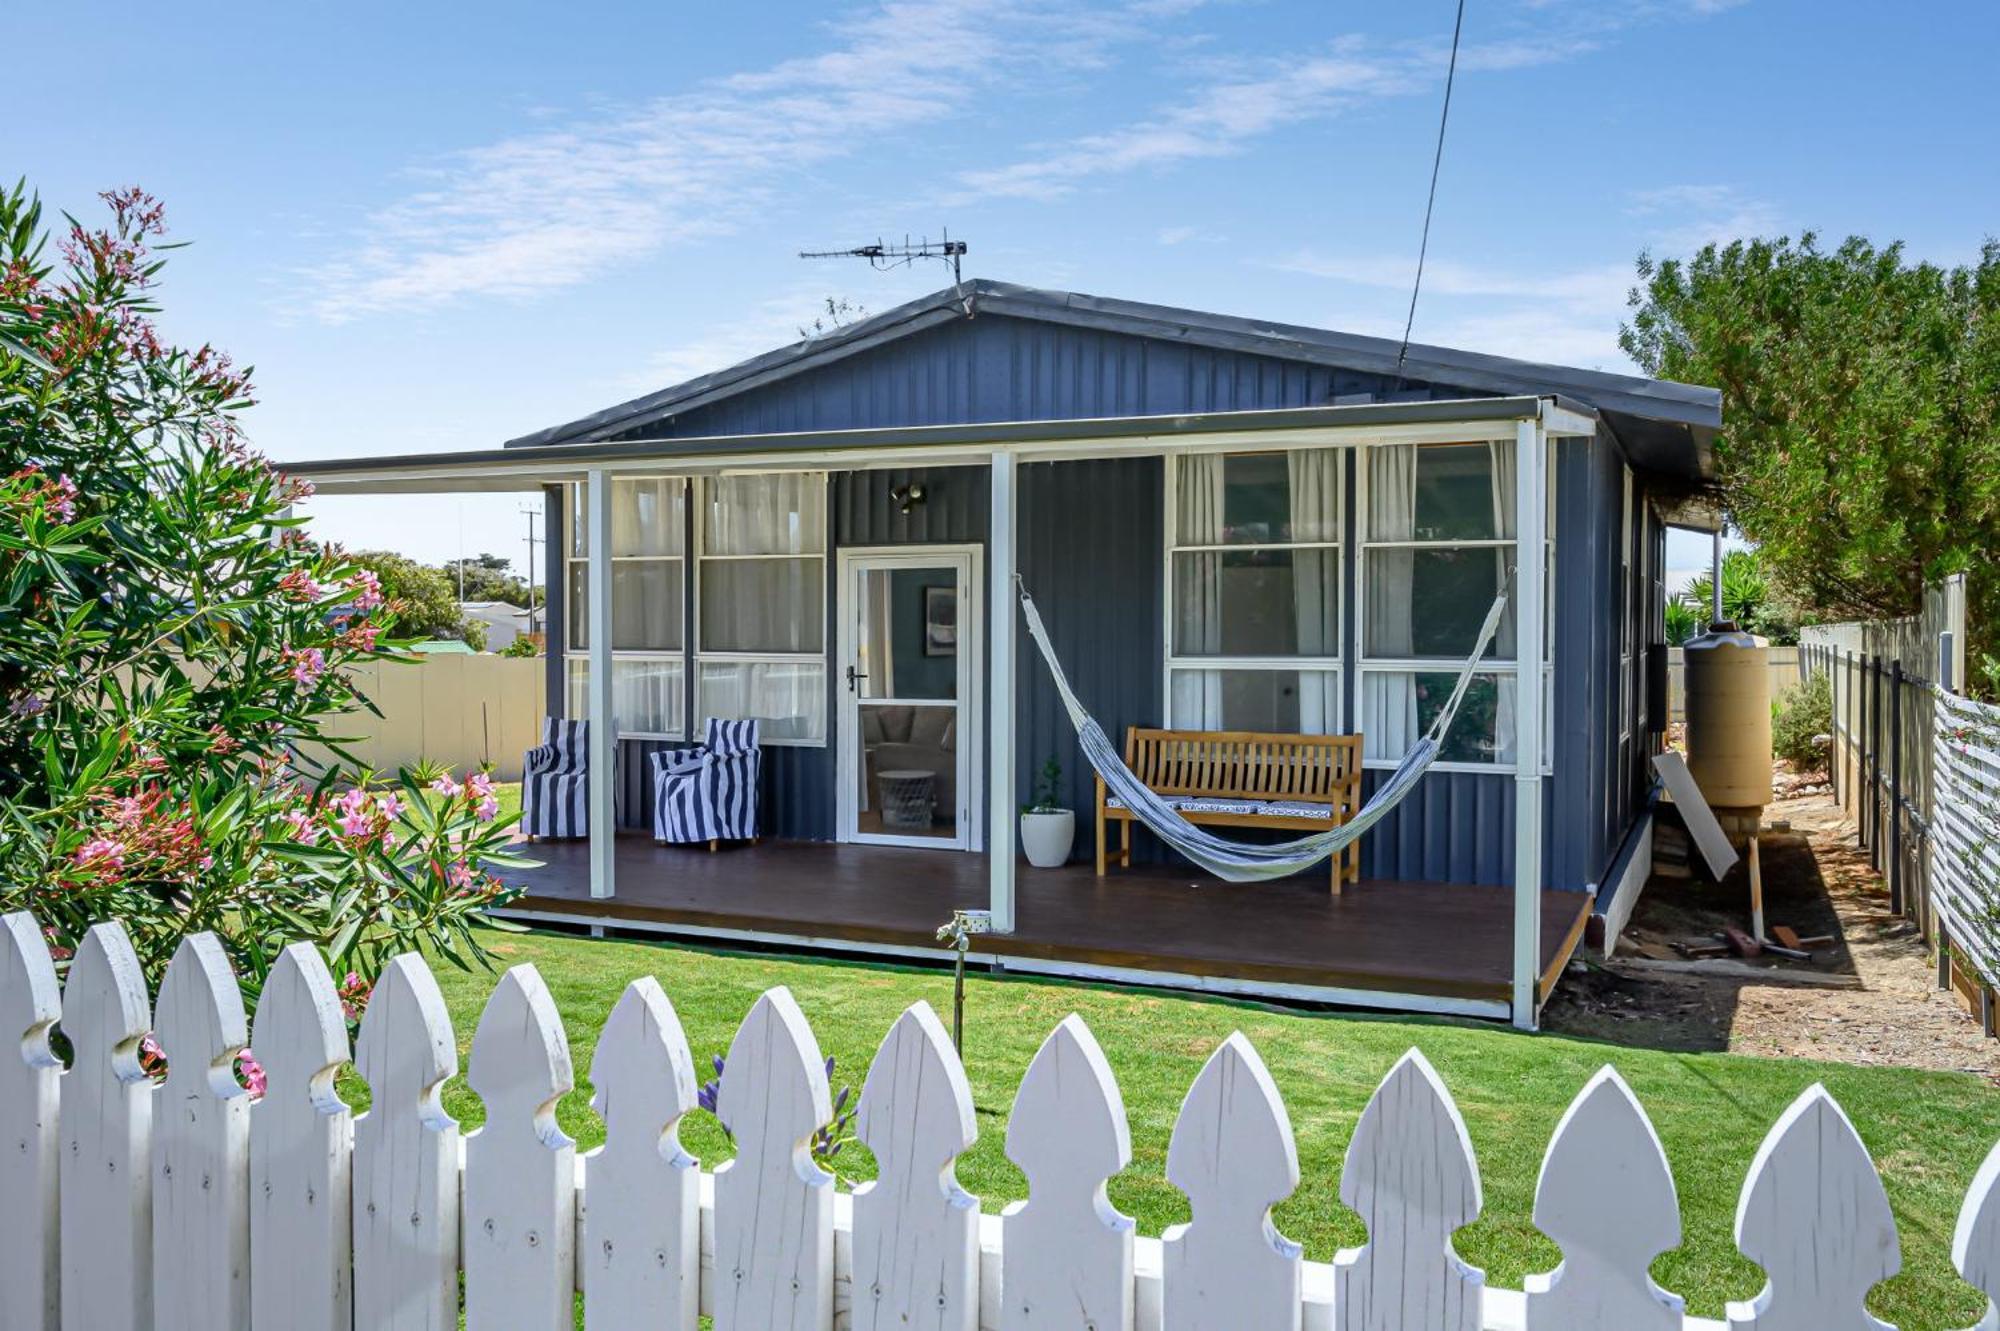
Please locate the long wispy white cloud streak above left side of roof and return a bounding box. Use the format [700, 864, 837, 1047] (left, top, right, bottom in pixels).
[294, 0, 1168, 322]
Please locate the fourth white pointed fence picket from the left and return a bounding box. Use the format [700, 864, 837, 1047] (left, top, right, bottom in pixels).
[250, 943, 354, 1331]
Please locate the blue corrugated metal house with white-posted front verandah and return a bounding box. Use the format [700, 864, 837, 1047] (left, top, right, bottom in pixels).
[294, 282, 1720, 1023]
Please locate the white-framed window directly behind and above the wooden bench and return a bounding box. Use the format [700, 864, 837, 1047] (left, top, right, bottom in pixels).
[1166, 448, 1346, 735]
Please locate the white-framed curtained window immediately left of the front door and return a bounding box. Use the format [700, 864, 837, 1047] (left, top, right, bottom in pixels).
[694, 472, 826, 745]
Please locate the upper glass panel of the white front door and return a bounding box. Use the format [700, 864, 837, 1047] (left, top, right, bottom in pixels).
[854, 566, 958, 701]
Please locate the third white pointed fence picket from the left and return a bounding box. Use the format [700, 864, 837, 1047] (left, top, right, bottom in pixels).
[152, 933, 250, 1331]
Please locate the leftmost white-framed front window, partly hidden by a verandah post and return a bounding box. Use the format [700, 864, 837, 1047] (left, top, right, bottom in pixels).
[562, 476, 688, 739]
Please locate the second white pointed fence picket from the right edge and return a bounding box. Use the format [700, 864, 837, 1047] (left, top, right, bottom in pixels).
[1728, 1085, 1902, 1331]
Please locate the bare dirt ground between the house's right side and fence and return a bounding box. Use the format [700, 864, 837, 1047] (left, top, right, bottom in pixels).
[1542, 771, 2000, 1083]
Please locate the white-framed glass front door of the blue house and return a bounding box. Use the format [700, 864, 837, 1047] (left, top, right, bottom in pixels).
[836, 546, 982, 849]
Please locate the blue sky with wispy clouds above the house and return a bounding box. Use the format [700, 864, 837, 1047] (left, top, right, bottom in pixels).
[19, 0, 2000, 583]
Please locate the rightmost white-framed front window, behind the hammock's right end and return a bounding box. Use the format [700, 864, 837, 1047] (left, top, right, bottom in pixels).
[1358, 438, 1528, 769]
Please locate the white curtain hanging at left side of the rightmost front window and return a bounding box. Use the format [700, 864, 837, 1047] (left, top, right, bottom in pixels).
[1362, 444, 1422, 759]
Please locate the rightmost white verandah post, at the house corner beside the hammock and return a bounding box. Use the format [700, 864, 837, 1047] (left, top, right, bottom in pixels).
[1512, 420, 1548, 1031]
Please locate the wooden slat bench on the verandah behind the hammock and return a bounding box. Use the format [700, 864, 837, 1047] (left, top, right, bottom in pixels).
[1098, 725, 1362, 893]
